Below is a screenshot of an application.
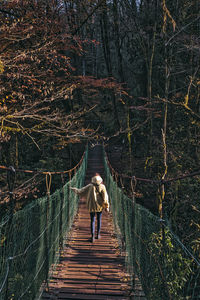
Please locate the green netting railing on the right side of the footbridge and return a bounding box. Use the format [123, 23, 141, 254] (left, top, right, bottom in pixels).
[104, 151, 200, 300]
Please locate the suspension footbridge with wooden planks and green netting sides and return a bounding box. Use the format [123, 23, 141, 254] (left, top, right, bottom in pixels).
[0, 145, 200, 300]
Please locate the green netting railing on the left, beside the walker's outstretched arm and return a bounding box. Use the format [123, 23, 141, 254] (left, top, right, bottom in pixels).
[0, 149, 88, 300]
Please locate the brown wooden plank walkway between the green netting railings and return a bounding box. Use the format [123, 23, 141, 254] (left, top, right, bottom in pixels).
[42, 147, 145, 300]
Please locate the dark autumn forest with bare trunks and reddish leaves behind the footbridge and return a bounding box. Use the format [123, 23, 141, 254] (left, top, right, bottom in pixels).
[0, 0, 200, 296]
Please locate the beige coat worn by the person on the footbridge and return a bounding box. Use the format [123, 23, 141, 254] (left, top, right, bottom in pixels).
[71, 177, 109, 212]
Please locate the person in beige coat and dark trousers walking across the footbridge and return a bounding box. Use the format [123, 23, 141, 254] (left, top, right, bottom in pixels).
[71, 173, 109, 243]
